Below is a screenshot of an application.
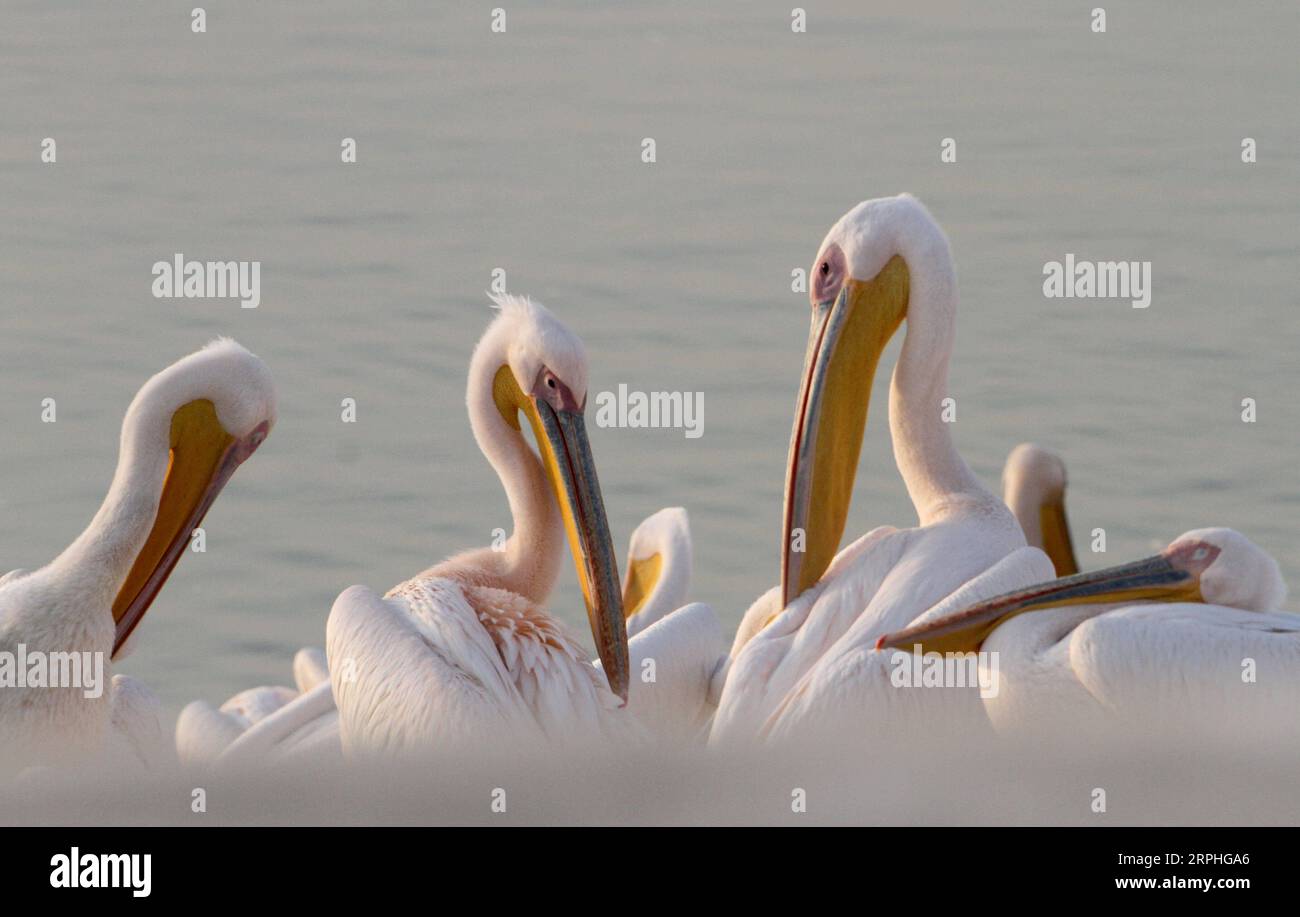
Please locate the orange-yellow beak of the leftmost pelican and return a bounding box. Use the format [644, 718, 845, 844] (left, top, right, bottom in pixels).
[113, 399, 270, 657]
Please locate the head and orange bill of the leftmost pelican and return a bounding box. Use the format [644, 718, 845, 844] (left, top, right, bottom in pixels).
[107, 338, 276, 656]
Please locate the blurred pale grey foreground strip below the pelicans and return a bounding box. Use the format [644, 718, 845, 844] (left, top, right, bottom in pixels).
[0, 739, 1300, 825]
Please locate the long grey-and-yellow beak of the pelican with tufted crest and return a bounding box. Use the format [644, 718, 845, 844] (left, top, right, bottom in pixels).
[529, 397, 632, 701]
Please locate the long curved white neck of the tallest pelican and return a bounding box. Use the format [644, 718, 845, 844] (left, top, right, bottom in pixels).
[889, 219, 993, 525]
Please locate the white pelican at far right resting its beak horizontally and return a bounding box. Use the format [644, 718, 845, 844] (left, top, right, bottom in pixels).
[879, 528, 1300, 738]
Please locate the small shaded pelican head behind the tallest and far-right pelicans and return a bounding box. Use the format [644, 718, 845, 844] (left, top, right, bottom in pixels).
[1002, 442, 1079, 576]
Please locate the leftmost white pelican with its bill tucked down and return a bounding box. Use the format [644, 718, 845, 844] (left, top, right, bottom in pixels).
[0, 339, 276, 765]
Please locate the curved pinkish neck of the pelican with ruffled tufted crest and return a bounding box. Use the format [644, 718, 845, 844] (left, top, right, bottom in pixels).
[465, 329, 564, 605]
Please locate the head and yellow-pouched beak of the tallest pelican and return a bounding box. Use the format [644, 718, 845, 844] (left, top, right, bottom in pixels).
[781, 194, 948, 606]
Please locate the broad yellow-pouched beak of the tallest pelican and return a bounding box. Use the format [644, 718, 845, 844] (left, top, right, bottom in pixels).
[781, 256, 909, 607]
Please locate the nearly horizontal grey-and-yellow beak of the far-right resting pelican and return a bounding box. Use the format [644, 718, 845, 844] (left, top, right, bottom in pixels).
[876, 541, 1219, 653]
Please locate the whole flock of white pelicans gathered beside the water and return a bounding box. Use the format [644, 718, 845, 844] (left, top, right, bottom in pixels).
[0, 195, 1300, 780]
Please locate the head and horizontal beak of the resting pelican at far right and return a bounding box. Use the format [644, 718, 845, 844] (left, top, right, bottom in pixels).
[876, 528, 1287, 653]
